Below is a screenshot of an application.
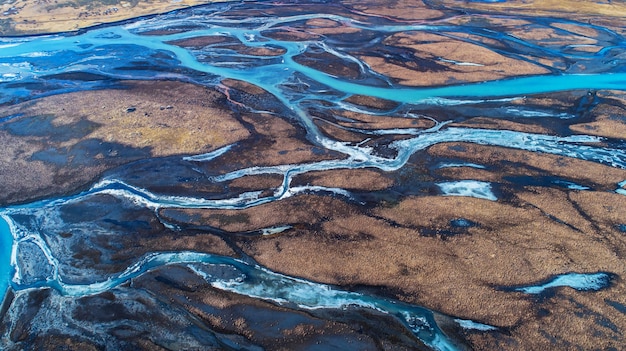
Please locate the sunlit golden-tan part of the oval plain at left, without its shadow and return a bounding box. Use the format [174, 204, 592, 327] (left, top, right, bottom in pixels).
[3, 82, 249, 157]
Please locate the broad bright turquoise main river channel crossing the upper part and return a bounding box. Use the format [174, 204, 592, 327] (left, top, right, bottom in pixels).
[0, 28, 626, 103]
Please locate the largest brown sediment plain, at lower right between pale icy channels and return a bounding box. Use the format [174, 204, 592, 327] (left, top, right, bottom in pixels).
[160, 184, 626, 350]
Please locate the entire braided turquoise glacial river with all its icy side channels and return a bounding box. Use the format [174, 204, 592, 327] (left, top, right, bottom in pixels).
[0, 1, 626, 350]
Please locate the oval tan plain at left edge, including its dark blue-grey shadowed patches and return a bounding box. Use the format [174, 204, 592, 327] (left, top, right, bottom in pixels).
[0, 82, 250, 204]
